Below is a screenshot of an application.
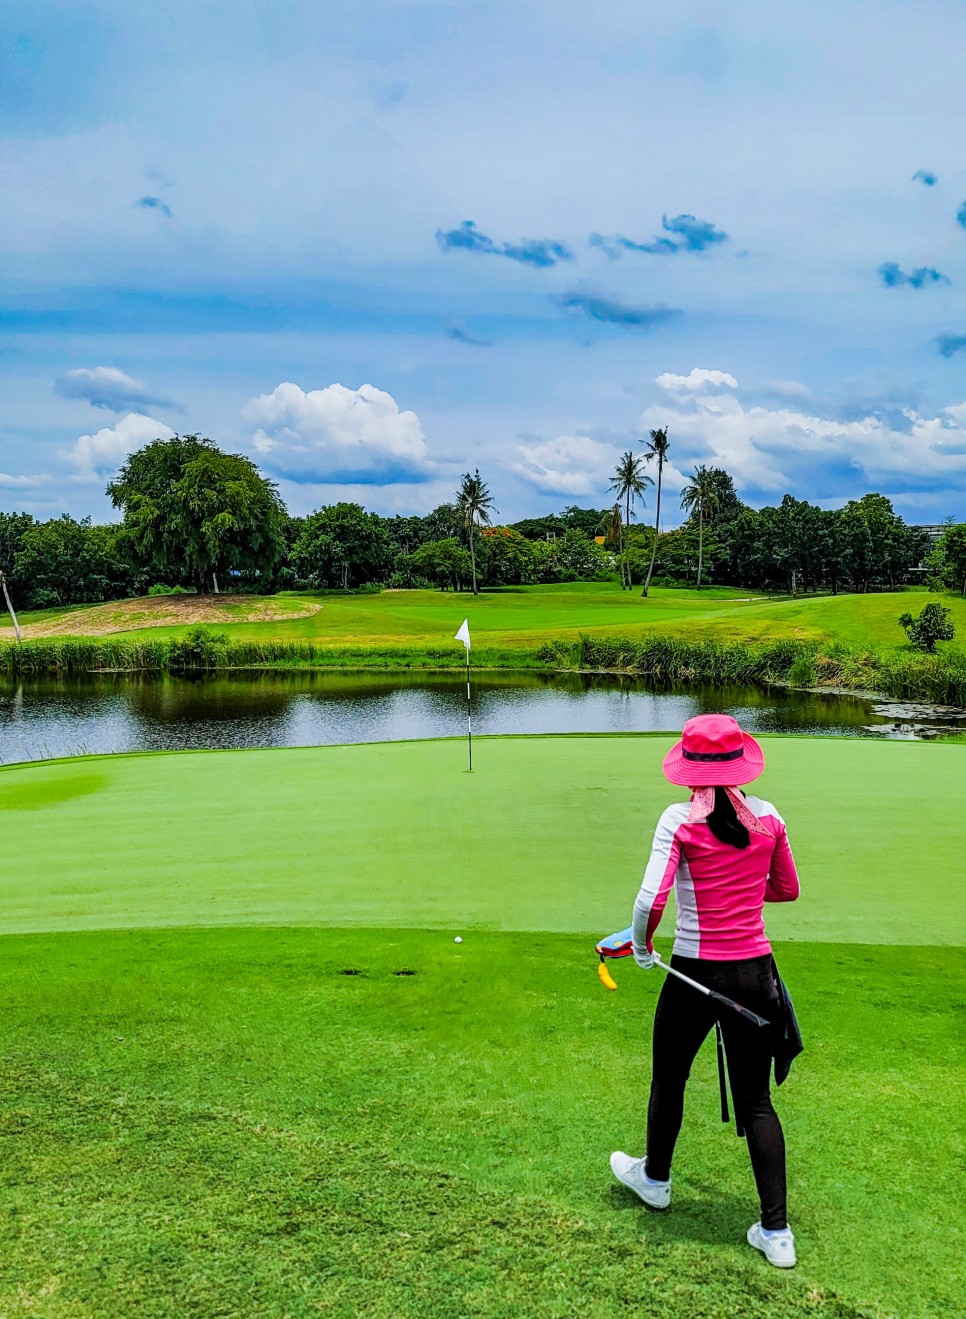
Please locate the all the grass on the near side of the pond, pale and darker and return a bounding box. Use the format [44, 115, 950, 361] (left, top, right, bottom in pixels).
[0, 737, 966, 1319]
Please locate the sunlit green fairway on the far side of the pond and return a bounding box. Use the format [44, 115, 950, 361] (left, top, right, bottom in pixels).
[7, 582, 966, 648]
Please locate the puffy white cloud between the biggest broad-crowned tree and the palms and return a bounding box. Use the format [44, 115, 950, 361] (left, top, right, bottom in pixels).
[243, 381, 434, 485]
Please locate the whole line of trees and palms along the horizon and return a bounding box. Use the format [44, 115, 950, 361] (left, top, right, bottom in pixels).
[0, 430, 966, 609]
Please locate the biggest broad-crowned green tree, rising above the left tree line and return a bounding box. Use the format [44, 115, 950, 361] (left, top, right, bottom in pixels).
[107, 435, 286, 594]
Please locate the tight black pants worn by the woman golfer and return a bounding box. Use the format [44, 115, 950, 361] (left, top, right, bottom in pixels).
[647, 956, 787, 1228]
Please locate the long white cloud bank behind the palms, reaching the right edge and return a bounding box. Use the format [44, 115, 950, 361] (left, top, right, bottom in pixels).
[643, 393, 966, 495]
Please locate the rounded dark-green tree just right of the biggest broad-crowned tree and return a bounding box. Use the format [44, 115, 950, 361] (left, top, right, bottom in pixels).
[292, 503, 393, 591]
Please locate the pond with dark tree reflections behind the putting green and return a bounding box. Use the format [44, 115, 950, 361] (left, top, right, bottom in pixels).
[0, 671, 966, 764]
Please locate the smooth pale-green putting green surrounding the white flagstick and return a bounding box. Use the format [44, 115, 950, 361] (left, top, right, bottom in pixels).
[0, 736, 966, 944]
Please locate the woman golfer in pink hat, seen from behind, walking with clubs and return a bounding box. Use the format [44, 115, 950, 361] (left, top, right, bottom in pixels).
[611, 715, 798, 1269]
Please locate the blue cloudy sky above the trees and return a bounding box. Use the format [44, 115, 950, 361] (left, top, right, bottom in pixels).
[0, 0, 966, 524]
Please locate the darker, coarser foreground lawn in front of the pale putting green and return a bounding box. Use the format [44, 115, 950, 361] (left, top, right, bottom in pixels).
[0, 929, 966, 1319]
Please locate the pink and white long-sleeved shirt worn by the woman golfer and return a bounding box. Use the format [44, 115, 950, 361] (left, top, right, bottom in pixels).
[633, 797, 798, 962]
